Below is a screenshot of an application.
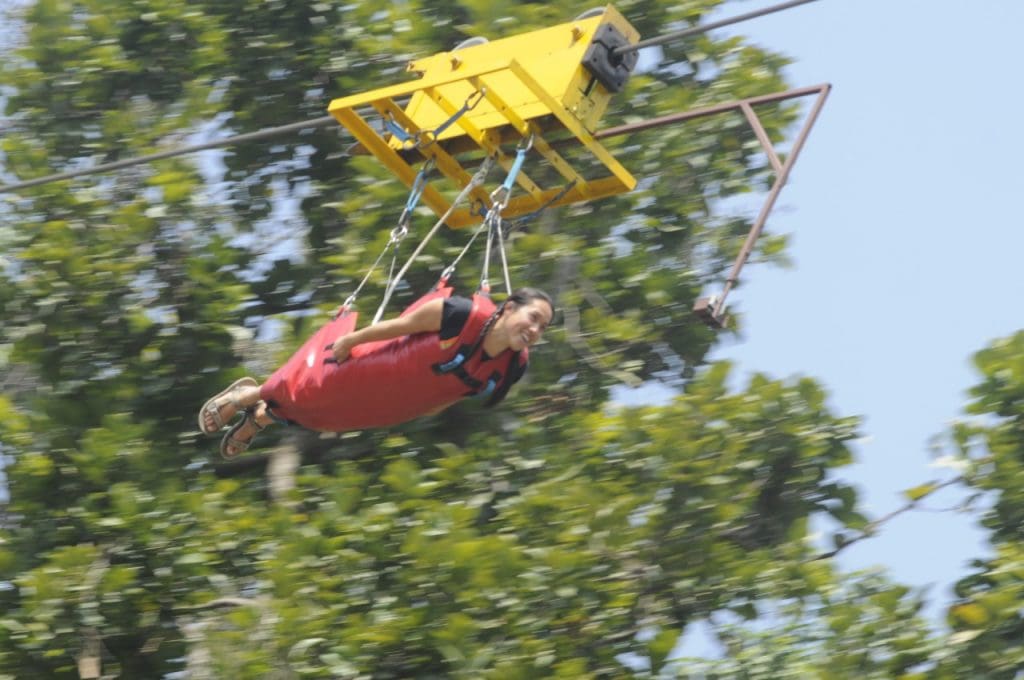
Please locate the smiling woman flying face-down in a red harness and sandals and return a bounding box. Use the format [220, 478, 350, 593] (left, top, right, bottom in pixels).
[199, 286, 554, 458]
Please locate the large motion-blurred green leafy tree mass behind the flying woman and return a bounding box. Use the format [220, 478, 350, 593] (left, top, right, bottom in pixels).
[0, 0, 970, 679]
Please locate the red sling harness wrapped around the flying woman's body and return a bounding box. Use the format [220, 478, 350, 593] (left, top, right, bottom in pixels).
[260, 287, 526, 432]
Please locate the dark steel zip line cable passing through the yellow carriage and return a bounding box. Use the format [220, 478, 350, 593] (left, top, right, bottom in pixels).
[0, 0, 816, 194]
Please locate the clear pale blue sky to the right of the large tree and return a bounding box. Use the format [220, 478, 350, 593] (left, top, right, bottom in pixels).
[700, 0, 1024, 617]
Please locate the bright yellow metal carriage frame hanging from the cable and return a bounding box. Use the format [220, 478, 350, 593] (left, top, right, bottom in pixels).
[328, 7, 639, 228]
